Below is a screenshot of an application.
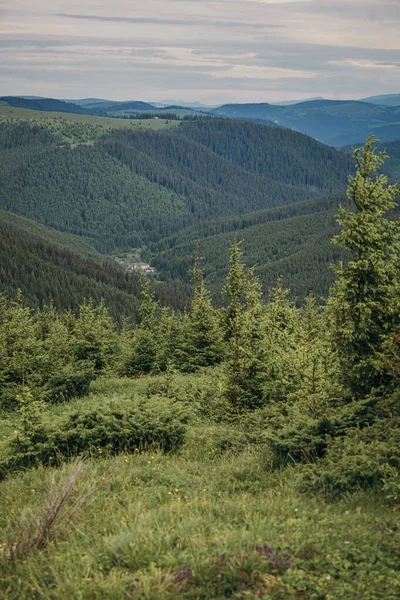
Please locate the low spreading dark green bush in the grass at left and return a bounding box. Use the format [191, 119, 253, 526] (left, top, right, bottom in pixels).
[0, 399, 188, 477]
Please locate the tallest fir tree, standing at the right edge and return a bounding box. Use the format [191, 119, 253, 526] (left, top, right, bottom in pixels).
[330, 135, 400, 397]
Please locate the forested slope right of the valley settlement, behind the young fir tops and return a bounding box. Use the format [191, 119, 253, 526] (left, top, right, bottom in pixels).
[148, 195, 346, 301]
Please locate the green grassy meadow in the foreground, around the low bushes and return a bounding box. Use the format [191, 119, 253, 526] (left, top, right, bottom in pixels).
[0, 376, 400, 600]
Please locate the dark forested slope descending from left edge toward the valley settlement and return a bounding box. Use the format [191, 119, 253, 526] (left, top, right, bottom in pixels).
[0, 210, 187, 322]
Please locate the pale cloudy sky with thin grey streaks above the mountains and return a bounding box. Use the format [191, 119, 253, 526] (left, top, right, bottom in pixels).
[0, 0, 400, 105]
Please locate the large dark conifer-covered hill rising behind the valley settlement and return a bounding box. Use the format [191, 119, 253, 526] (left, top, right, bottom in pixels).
[0, 120, 351, 252]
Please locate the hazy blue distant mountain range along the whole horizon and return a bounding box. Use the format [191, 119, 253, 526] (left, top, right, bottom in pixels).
[0, 94, 400, 147]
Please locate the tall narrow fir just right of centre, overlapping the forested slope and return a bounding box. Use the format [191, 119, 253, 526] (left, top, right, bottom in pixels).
[224, 239, 265, 410]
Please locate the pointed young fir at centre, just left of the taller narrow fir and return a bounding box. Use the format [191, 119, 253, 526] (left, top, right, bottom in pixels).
[176, 250, 225, 372]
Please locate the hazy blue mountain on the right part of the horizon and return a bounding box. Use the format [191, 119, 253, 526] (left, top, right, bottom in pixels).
[211, 100, 400, 147]
